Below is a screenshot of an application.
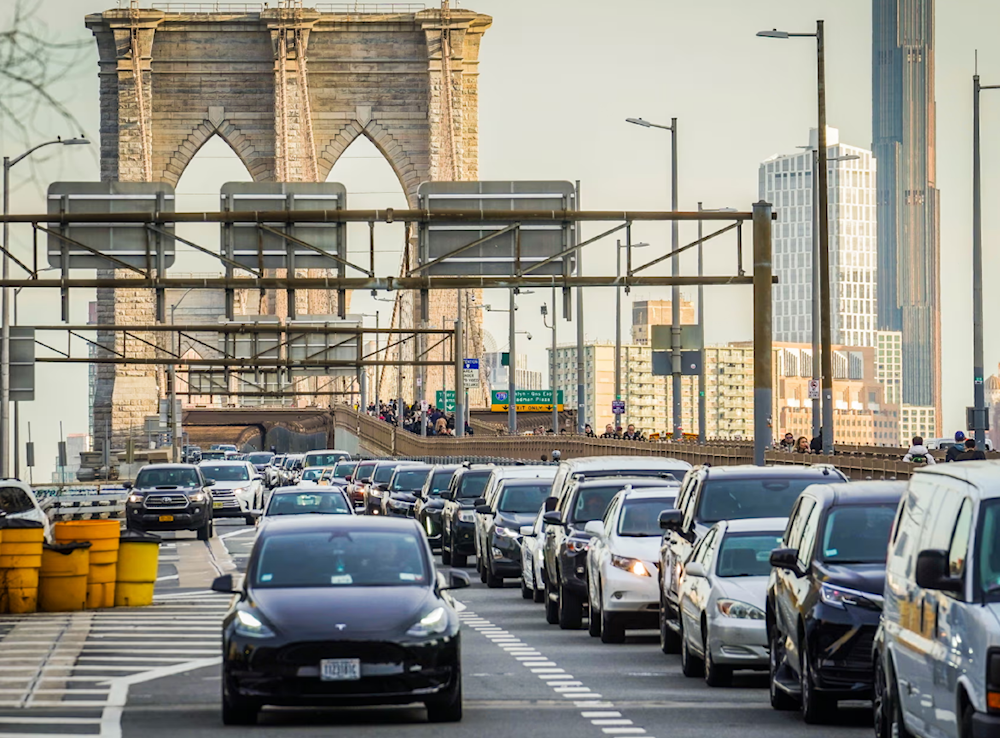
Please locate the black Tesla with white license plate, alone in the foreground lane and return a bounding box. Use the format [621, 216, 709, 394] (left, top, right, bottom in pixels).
[212, 515, 469, 725]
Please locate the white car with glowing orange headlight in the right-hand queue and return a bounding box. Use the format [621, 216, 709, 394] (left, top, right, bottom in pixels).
[584, 486, 677, 643]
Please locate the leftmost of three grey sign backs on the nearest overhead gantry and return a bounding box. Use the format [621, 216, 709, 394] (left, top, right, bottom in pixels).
[47, 182, 174, 276]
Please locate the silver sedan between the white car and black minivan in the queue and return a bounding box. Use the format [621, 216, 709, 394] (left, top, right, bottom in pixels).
[678, 518, 788, 687]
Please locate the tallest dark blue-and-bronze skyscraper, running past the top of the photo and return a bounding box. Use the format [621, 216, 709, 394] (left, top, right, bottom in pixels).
[872, 0, 941, 426]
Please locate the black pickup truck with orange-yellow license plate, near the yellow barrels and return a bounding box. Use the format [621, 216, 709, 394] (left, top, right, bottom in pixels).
[125, 464, 215, 541]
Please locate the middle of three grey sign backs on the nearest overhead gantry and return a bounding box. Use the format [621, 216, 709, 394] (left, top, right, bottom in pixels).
[220, 182, 347, 269]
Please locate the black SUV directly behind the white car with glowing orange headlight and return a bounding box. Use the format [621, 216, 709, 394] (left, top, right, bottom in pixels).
[542, 476, 677, 630]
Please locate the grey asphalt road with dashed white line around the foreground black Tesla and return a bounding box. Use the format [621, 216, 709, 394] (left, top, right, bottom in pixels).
[119, 521, 871, 738]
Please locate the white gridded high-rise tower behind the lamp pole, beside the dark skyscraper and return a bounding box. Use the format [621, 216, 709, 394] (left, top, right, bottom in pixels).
[759, 128, 877, 346]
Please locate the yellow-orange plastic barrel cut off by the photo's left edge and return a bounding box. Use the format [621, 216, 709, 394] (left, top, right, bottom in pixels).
[0, 518, 45, 613]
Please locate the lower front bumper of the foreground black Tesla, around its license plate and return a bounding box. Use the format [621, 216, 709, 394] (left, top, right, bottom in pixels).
[223, 636, 460, 705]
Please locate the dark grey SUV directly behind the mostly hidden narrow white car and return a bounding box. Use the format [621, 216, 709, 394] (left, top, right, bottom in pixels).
[476, 478, 552, 589]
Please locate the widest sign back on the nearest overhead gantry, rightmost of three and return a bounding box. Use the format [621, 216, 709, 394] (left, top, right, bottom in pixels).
[417, 182, 576, 276]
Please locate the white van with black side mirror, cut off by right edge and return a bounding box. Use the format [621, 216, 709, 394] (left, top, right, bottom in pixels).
[873, 461, 1000, 738]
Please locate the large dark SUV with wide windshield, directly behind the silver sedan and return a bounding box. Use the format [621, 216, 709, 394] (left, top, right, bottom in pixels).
[658, 464, 847, 653]
